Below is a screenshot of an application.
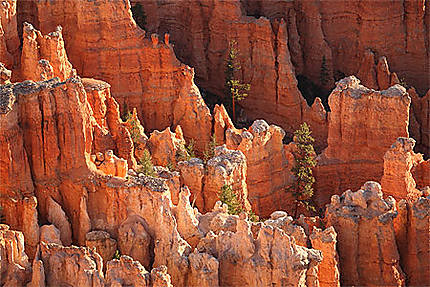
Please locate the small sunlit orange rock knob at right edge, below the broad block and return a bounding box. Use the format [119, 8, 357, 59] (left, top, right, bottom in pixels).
[381, 138, 423, 202]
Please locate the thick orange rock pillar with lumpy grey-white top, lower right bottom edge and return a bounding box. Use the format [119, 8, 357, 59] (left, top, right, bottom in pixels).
[326, 182, 405, 286]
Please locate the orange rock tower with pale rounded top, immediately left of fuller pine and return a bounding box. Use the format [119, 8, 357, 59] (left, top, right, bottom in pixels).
[226, 120, 294, 217]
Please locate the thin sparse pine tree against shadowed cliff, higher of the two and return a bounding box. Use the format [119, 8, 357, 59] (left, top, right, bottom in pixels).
[224, 40, 251, 122]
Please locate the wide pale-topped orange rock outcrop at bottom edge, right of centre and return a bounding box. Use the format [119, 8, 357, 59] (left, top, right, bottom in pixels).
[198, 213, 322, 286]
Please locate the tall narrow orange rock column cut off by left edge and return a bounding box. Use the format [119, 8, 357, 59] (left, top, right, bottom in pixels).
[0, 73, 39, 257]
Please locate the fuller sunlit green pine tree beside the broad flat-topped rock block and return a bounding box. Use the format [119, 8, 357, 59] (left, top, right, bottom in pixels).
[288, 123, 316, 217]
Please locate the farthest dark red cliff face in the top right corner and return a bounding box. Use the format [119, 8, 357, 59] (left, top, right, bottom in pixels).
[242, 0, 430, 92]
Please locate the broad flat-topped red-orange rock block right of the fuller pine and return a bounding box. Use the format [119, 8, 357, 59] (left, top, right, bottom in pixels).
[314, 76, 411, 206]
